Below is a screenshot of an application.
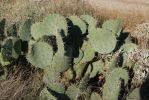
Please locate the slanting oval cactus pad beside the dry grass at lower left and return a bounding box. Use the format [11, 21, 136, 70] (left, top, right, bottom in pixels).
[43, 66, 65, 94]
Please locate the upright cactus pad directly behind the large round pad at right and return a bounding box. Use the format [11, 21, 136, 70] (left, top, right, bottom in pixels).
[102, 19, 123, 36]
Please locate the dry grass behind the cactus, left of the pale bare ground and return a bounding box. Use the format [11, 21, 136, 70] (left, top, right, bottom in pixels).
[0, 0, 107, 26]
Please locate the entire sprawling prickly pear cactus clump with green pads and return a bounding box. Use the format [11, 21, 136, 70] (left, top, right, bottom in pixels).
[0, 14, 149, 100]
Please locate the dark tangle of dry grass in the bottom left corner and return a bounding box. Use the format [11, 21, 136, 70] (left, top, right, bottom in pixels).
[0, 58, 44, 100]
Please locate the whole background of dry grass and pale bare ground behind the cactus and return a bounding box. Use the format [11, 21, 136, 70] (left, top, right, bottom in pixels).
[0, 0, 149, 31]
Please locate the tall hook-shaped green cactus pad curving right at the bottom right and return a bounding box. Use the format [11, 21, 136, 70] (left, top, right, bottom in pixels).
[103, 68, 129, 100]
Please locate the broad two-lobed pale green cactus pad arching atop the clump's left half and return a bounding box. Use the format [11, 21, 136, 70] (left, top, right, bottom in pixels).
[31, 14, 68, 40]
